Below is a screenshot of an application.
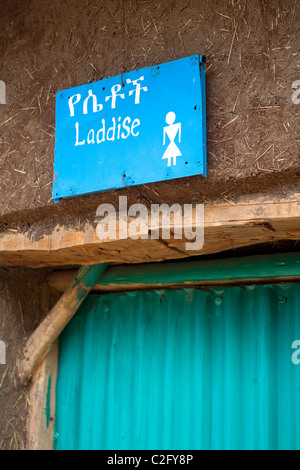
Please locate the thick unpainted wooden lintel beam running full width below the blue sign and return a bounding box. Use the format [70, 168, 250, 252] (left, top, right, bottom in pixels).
[0, 193, 300, 268]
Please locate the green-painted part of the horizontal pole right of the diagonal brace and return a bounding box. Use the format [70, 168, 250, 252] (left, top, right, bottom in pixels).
[89, 253, 300, 286]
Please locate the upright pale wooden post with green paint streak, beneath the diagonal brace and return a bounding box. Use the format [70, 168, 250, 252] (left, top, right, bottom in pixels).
[26, 341, 58, 450]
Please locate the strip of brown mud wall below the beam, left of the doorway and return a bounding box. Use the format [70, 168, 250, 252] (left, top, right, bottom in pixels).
[0, 269, 56, 450]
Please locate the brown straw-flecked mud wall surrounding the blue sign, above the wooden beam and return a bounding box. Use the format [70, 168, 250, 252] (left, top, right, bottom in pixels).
[0, 0, 300, 230]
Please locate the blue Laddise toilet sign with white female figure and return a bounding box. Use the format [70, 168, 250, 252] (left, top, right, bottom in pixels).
[53, 55, 206, 202]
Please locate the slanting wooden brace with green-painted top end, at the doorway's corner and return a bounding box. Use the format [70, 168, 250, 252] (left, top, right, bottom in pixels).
[18, 264, 107, 385]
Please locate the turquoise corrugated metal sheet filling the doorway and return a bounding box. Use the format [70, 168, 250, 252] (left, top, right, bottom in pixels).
[55, 285, 300, 450]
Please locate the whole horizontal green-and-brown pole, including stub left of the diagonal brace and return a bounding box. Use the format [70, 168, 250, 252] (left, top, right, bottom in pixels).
[48, 253, 300, 292]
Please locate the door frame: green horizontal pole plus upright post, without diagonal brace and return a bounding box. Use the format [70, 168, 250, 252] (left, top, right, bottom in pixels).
[27, 252, 300, 450]
